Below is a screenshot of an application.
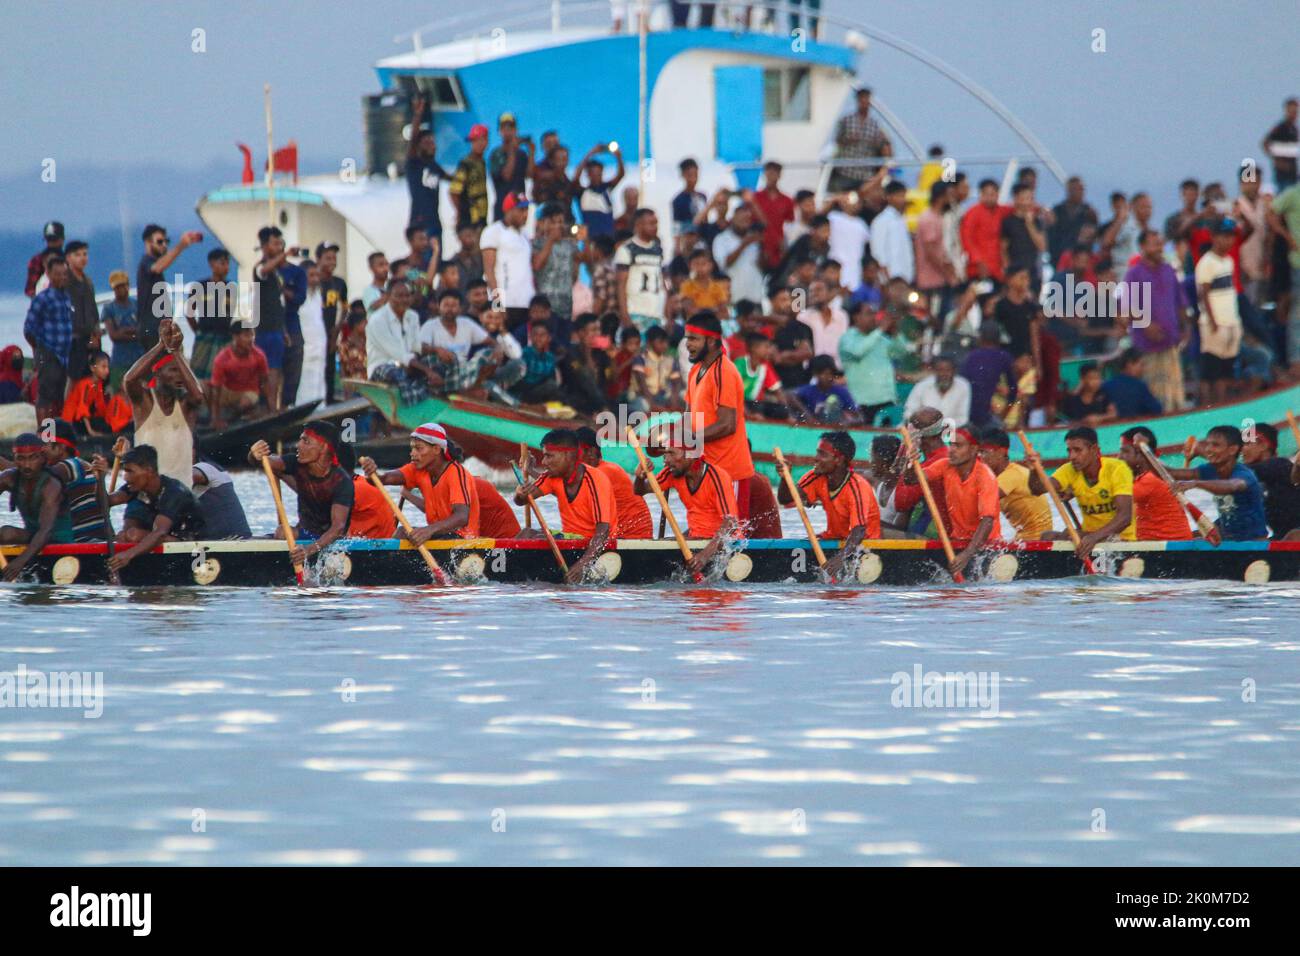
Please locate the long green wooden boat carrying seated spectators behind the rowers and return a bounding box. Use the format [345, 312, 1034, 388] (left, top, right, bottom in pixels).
[347, 380, 1300, 481]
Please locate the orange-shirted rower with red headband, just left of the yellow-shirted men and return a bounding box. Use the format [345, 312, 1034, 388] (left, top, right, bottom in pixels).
[902, 428, 1002, 578]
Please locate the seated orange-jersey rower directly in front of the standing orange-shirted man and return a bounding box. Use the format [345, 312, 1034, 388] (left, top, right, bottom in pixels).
[633, 436, 742, 574]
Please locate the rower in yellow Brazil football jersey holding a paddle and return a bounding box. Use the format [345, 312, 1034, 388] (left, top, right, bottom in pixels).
[1026, 425, 1138, 558]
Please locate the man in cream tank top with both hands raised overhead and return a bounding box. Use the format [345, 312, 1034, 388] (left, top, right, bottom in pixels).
[122, 319, 203, 489]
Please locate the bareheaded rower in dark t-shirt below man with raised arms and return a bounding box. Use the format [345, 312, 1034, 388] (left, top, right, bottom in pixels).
[95, 444, 208, 571]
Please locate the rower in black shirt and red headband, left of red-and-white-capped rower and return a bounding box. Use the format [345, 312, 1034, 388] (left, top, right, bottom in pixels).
[248, 421, 356, 564]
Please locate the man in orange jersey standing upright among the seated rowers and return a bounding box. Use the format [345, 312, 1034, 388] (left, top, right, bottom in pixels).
[685, 310, 781, 537]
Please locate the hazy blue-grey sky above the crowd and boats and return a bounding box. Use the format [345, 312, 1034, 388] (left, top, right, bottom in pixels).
[0, 0, 1300, 217]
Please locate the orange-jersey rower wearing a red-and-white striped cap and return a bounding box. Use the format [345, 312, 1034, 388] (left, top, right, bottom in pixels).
[361, 421, 478, 545]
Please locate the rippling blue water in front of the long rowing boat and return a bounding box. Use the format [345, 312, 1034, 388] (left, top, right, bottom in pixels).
[0, 475, 1300, 865]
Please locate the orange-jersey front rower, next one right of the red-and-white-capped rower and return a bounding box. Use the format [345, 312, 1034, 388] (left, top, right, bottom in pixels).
[515, 428, 619, 584]
